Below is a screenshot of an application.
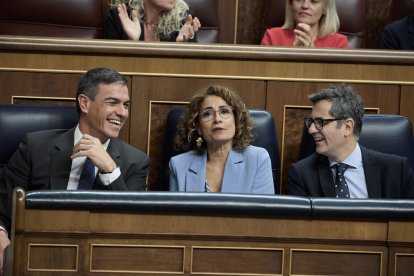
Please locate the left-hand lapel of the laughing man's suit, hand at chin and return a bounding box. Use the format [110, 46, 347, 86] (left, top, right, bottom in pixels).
[50, 128, 75, 190]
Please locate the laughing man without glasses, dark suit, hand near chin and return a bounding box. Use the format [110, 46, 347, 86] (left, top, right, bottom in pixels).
[0, 68, 149, 268]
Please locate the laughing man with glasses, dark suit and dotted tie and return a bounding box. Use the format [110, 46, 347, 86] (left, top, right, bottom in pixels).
[288, 85, 414, 199]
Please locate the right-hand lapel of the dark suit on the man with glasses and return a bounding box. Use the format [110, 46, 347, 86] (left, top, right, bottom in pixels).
[360, 146, 382, 198]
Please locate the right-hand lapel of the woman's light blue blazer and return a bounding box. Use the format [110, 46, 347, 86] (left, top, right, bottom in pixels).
[221, 150, 244, 193]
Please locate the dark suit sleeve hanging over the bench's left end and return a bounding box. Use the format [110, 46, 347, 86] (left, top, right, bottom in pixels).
[0, 136, 30, 232]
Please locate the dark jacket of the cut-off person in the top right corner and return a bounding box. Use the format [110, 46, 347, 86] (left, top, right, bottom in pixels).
[381, 14, 414, 50]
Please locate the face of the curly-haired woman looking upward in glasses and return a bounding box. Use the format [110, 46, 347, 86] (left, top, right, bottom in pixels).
[197, 96, 236, 148]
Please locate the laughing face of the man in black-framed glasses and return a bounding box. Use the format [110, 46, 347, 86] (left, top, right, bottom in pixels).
[308, 100, 356, 162]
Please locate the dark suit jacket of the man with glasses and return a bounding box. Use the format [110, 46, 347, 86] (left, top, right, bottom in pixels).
[288, 146, 414, 199]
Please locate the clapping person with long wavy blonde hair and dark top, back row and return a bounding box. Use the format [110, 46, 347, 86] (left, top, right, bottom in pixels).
[104, 0, 201, 42]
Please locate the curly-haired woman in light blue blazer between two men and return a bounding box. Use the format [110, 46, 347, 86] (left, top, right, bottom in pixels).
[169, 85, 275, 194]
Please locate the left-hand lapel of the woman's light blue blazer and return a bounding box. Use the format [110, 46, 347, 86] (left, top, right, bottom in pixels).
[185, 150, 207, 192]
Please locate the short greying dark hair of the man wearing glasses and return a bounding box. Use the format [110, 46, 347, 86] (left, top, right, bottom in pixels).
[309, 84, 364, 137]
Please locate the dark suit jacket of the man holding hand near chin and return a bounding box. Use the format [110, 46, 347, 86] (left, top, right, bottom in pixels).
[0, 128, 149, 230]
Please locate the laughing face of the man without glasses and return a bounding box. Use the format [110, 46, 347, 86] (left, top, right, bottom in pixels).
[78, 83, 130, 143]
